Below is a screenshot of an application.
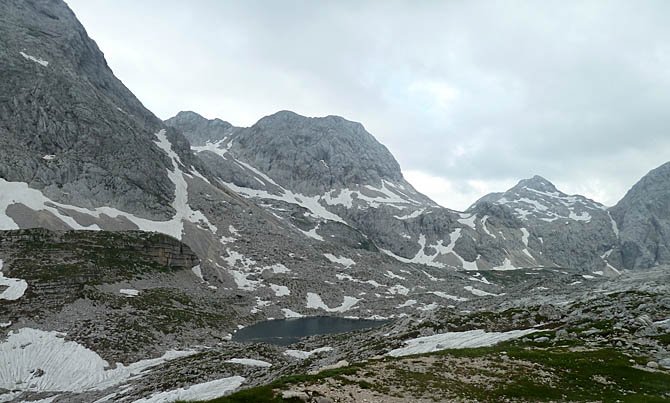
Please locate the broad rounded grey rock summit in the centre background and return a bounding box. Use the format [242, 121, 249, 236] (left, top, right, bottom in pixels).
[166, 111, 404, 195]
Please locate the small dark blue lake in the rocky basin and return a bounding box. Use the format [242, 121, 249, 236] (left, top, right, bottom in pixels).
[233, 316, 388, 346]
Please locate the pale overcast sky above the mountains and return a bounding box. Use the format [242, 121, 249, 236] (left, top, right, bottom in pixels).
[67, 0, 670, 209]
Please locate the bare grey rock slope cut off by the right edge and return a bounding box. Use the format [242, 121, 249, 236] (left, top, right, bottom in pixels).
[610, 163, 670, 269]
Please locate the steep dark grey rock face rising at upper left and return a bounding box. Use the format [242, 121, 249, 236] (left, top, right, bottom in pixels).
[0, 0, 197, 218]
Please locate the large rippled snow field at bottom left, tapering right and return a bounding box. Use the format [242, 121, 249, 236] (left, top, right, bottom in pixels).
[0, 328, 195, 392]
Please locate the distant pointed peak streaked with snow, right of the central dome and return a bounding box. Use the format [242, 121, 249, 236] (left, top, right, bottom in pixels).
[467, 176, 621, 271]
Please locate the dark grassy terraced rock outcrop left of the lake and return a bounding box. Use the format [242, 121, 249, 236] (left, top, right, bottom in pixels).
[0, 229, 211, 361]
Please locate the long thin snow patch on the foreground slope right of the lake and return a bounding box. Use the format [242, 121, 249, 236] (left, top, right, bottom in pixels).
[388, 329, 537, 357]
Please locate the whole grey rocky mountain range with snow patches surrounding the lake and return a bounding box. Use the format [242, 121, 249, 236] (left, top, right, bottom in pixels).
[0, 0, 670, 402]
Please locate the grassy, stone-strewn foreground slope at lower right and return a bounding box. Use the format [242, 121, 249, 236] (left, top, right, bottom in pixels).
[177, 269, 670, 402]
